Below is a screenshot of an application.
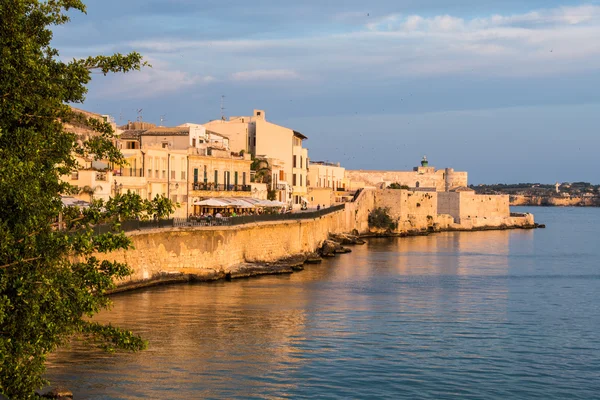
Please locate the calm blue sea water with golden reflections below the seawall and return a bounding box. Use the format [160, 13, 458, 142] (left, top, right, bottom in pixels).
[48, 207, 600, 399]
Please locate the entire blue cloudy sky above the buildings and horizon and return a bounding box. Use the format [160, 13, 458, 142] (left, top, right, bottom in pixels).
[53, 0, 600, 184]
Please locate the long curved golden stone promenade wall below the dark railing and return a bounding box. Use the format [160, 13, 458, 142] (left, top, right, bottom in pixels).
[99, 211, 352, 286]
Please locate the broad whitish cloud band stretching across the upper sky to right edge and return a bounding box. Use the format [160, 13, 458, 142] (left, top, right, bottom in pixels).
[90, 5, 600, 88]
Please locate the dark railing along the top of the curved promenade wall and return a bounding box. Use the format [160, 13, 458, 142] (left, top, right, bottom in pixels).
[94, 204, 345, 235]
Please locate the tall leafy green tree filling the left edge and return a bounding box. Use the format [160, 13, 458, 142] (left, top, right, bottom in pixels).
[0, 0, 172, 399]
